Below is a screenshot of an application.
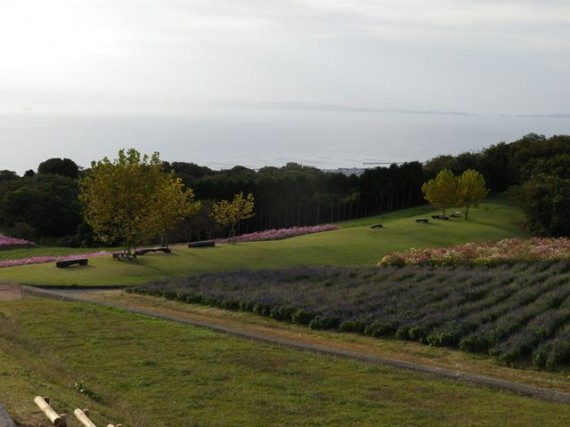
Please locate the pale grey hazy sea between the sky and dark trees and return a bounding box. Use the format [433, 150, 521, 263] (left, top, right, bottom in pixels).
[0, 109, 570, 174]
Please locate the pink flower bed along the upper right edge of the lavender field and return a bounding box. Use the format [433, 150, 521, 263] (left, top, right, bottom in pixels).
[380, 237, 570, 266]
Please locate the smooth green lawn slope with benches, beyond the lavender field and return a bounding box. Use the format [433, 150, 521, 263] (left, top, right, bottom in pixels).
[0, 199, 527, 286]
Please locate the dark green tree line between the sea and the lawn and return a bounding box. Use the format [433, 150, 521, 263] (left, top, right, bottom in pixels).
[0, 134, 570, 246]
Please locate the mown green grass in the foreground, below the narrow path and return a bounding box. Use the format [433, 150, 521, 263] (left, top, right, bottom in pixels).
[0, 300, 568, 427]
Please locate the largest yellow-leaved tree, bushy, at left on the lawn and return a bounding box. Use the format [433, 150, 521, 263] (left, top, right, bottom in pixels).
[80, 148, 195, 256]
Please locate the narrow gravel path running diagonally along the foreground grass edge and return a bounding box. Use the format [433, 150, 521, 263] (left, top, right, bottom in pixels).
[23, 286, 570, 404]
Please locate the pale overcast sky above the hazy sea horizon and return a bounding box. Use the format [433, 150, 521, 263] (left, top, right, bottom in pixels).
[0, 0, 570, 169]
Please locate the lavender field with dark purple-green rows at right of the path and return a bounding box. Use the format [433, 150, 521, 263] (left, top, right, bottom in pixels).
[131, 261, 570, 370]
